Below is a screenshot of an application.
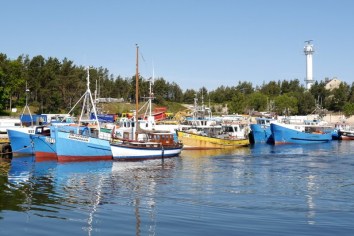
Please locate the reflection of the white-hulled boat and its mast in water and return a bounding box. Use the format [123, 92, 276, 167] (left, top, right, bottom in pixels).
[112, 157, 178, 235]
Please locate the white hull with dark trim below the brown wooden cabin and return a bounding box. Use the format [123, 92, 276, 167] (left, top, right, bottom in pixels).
[111, 143, 182, 161]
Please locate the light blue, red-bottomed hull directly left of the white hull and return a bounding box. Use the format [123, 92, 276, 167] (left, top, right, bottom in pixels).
[55, 127, 112, 161]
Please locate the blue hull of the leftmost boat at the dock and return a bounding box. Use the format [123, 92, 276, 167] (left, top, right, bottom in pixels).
[7, 128, 34, 155]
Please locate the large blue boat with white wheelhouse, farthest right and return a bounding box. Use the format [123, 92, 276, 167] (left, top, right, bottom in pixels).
[270, 120, 333, 144]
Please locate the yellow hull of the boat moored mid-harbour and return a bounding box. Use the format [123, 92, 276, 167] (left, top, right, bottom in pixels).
[177, 131, 250, 149]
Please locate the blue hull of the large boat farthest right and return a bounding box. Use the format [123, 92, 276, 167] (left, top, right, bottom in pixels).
[270, 124, 332, 144]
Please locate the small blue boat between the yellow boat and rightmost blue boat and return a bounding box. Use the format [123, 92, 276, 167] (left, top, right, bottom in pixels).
[250, 117, 276, 144]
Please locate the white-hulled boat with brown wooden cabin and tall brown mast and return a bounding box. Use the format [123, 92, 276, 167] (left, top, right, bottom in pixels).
[111, 46, 183, 161]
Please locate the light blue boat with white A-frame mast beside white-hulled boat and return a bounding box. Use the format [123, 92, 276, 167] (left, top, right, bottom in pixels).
[53, 68, 112, 161]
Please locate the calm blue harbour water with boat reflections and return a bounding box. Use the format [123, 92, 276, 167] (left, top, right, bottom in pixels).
[0, 141, 354, 236]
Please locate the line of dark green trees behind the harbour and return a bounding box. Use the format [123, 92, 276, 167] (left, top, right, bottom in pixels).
[0, 53, 354, 116]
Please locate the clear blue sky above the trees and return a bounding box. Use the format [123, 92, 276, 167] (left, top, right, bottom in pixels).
[0, 0, 354, 91]
